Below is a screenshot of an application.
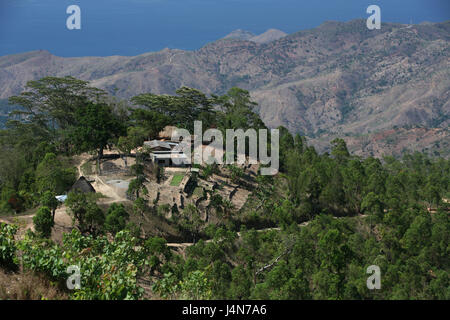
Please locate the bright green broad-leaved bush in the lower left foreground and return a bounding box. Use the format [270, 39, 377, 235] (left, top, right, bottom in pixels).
[19, 230, 156, 300]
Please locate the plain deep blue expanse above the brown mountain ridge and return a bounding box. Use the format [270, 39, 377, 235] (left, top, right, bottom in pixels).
[0, 0, 450, 56]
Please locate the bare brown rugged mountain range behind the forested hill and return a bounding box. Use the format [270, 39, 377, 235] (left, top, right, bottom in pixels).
[0, 20, 450, 156]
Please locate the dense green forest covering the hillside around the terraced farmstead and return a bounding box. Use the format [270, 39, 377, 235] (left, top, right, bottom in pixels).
[0, 77, 450, 299]
